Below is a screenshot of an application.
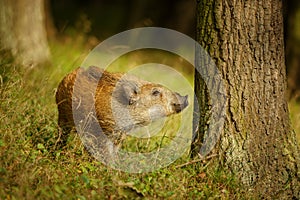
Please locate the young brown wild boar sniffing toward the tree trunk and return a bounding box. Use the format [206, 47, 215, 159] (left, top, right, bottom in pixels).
[56, 67, 188, 146]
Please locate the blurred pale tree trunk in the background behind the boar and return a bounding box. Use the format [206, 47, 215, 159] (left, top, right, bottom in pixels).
[0, 0, 50, 66]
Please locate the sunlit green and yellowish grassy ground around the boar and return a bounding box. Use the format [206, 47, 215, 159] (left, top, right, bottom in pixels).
[0, 39, 300, 199]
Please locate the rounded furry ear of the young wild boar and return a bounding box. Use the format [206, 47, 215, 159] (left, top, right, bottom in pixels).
[115, 82, 139, 105]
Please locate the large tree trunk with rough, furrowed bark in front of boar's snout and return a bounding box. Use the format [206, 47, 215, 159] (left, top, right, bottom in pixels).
[192, 0, 300, 199]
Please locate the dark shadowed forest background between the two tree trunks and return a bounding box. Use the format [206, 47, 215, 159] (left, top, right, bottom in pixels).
[47, 0, 196, 40]
